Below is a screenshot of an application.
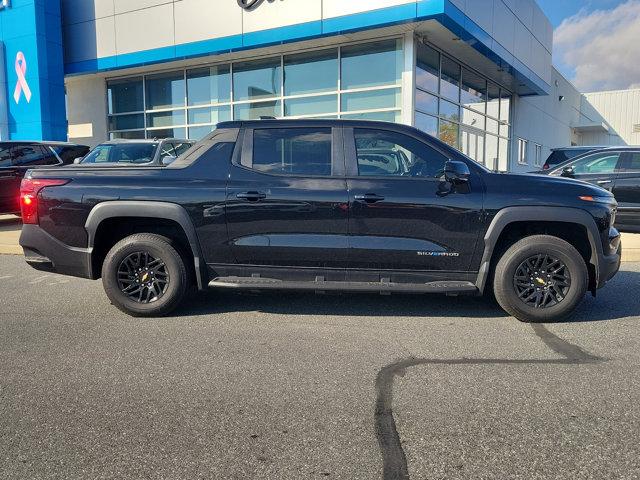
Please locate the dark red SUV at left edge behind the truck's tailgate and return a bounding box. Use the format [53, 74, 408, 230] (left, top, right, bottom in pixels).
[0, 142, 89, 214]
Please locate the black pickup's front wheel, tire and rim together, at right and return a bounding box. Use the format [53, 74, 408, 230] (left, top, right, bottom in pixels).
[493, 235, 589, 323]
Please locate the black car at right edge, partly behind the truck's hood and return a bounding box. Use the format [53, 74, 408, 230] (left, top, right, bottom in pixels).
[546, 147, 640, 233]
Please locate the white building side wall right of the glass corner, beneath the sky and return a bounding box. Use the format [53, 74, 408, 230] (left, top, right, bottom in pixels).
[510, 68, 625, 172]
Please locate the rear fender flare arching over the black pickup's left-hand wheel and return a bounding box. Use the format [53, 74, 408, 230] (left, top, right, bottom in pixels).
[85, 201, 209, 290]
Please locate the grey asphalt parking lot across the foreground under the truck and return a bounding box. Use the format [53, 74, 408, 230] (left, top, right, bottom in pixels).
[0, 256, 640, 480]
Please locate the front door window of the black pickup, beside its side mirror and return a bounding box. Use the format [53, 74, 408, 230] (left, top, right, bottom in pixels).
[354, 129, 447, 178]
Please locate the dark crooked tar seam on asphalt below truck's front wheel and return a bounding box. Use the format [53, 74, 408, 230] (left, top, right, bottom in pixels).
[374, 325, 606, 480]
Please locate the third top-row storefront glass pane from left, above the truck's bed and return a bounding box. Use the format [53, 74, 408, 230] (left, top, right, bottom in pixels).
[187, 65, 231, 106]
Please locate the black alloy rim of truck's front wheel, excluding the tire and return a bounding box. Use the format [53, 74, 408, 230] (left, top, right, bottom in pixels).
[513, 254, 571, 308]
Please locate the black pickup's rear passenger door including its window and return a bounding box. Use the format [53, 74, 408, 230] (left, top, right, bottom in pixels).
[226, 124, 348, 280]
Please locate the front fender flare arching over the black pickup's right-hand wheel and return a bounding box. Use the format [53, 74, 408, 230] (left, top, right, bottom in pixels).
[476, 207, 604, 292]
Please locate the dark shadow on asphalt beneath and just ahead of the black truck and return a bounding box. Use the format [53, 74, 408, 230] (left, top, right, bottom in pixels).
[176, 270, 640, 323]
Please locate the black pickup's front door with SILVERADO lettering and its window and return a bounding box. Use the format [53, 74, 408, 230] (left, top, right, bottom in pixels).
[345, 127, 483, 280]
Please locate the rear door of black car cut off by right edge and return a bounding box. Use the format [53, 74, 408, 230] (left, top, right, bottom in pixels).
[613, 152, 640, 233]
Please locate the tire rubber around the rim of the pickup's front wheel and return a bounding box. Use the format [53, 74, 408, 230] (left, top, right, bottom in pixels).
[495, 240, 589, 322]
